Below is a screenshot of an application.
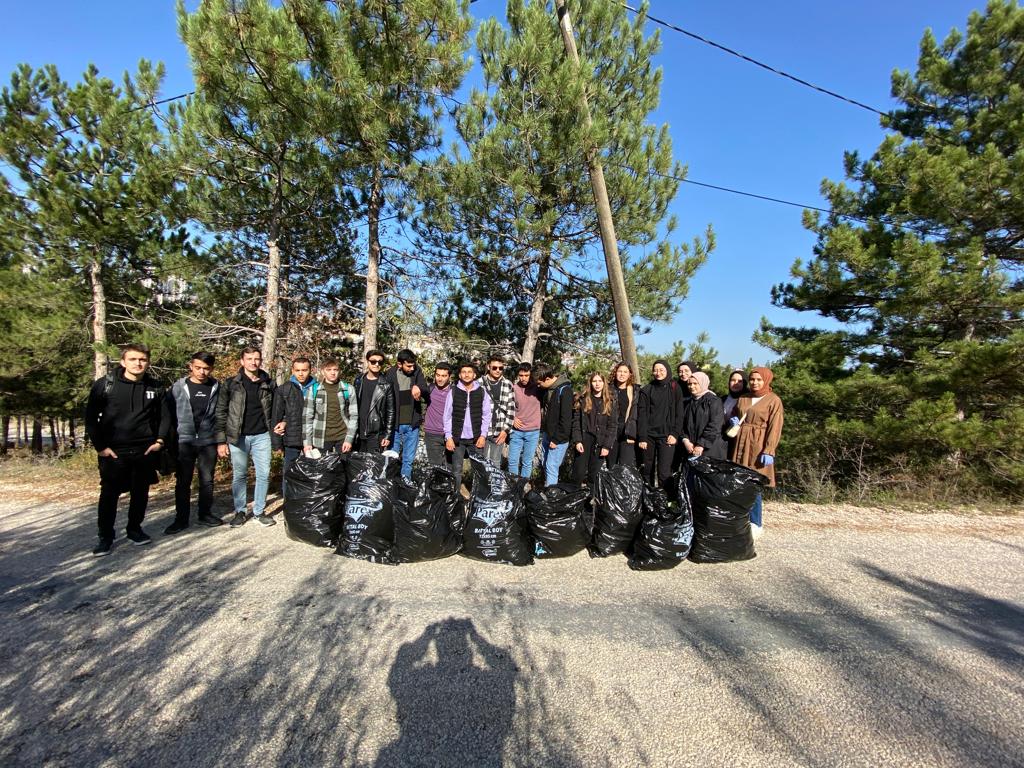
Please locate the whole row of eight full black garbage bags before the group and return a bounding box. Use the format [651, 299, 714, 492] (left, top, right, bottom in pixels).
[285, 453, 764, 570]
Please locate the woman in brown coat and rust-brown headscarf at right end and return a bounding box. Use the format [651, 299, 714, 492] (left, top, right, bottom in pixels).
[729, 367, 782, 536]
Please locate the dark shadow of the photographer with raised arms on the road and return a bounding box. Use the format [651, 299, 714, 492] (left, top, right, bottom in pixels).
[377, 618, 518, 768]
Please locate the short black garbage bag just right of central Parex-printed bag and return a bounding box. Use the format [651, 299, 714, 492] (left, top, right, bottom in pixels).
[526, 482, 594, 558]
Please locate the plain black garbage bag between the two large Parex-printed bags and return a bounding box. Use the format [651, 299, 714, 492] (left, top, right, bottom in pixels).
[394, 467, 466, 562]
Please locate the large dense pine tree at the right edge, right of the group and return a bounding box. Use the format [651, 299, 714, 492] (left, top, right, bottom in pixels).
[759, 0, 1024, 501]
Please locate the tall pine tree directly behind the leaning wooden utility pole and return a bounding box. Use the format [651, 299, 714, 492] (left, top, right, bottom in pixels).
[418, 0, 713, 359]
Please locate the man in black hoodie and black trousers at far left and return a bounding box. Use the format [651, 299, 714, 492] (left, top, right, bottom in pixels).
[85, 344, 171, 557]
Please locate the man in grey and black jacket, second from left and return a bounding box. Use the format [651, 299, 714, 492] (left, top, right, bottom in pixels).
[164, 352, 223, 535]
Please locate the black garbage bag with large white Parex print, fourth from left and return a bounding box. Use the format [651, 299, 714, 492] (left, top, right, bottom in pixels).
[462, 456, 534, 565]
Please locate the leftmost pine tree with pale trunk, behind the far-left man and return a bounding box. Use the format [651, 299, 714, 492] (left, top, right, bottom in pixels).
[0, 60, 191, 385]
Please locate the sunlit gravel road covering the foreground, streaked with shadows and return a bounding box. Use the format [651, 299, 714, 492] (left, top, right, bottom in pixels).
[0, 478, 1024, 768]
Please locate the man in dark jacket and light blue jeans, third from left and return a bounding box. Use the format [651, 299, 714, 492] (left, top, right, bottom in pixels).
[215, 347, 276, 528]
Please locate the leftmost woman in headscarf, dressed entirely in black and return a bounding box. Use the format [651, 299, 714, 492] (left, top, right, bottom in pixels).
[637, 360, 683, 492]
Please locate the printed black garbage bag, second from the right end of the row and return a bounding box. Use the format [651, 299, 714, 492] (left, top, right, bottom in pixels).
[629, 482, 693, 570]
